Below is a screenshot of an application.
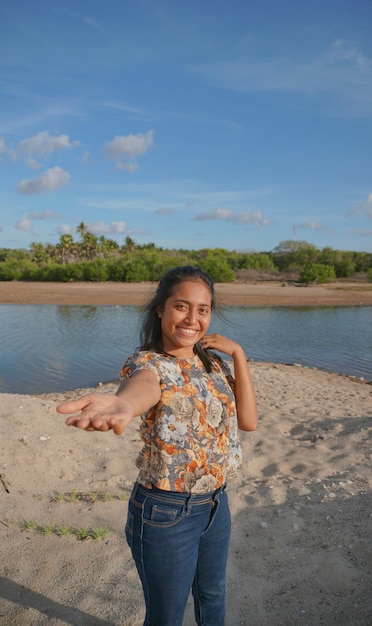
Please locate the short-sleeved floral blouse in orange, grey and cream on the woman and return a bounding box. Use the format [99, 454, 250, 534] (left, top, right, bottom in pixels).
[121, 351, 241, 493]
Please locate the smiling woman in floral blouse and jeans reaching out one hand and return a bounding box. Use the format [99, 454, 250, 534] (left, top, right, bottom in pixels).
[57, 266, 257, 626]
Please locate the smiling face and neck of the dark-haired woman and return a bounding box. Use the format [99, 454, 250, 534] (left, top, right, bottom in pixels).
[158, 280, 212, 358]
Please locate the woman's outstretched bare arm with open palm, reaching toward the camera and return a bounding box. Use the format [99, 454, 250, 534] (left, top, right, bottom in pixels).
[57, 369, 160, 435]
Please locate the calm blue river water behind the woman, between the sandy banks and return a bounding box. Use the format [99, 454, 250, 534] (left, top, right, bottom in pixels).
[0, 305, 372, 394]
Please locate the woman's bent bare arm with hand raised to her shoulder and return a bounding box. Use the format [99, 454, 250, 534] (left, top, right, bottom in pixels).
[201, 334, 257, 430]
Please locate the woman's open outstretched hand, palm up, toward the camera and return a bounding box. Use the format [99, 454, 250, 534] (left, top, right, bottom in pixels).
[57, 393, 133, 435]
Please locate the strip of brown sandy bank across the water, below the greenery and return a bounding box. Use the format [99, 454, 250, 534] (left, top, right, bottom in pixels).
[0, 281, 372, 306]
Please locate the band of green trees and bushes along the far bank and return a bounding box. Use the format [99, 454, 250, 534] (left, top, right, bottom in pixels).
[0, 222, 372, 283]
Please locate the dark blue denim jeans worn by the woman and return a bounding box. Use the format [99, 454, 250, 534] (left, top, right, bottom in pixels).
[125, 484, 231, 626]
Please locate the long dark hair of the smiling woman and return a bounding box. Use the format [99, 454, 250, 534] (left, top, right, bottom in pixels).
[140, 265, 216, 372]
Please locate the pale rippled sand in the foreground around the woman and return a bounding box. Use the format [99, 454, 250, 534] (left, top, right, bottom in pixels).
[0, 284, 372, 626]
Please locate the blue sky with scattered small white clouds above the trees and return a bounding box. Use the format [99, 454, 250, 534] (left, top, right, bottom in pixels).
[0, 0, 372, 251]
